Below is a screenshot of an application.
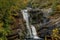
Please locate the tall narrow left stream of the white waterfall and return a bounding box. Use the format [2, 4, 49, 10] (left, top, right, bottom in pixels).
[21, 10, 32, 37]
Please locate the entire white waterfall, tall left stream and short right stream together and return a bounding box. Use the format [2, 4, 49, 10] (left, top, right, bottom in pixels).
[22, 9, 40, 39]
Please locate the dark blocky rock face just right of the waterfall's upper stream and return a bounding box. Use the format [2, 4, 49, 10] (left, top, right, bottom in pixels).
[29, 9, 43, 24]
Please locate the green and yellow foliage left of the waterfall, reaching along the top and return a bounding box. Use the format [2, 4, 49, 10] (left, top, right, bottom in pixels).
[0, 0, 28, 40]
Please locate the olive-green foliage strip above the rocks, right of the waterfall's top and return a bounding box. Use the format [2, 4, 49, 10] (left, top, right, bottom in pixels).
[31, 0, 60, 8]
